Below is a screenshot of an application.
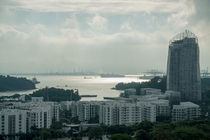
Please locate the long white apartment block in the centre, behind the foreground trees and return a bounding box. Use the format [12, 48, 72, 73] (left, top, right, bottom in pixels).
[99, 102, 156, 125]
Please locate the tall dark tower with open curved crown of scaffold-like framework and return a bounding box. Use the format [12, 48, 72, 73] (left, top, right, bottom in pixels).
[167, 30, 201, 102]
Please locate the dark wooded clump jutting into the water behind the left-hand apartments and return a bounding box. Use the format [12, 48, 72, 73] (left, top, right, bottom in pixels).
[31, 87, 80, 102]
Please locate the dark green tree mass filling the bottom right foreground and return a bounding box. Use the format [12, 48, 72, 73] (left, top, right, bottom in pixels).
[80, 118, 210, 140]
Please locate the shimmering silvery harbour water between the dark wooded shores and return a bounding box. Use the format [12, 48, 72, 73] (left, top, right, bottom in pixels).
[0, 75, 146, 101]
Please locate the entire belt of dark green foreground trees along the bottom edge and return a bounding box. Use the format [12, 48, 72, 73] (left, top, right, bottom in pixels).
[0, 118, 210, 140]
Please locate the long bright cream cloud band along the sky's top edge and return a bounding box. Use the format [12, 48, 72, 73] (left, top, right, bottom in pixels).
[7, 0, 187, 14]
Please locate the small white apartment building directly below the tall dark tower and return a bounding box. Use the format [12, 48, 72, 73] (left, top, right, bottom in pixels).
[172, 102, 200, 121]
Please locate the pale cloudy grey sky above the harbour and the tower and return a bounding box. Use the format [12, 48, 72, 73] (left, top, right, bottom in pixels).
[0, 0, 210, 73]
